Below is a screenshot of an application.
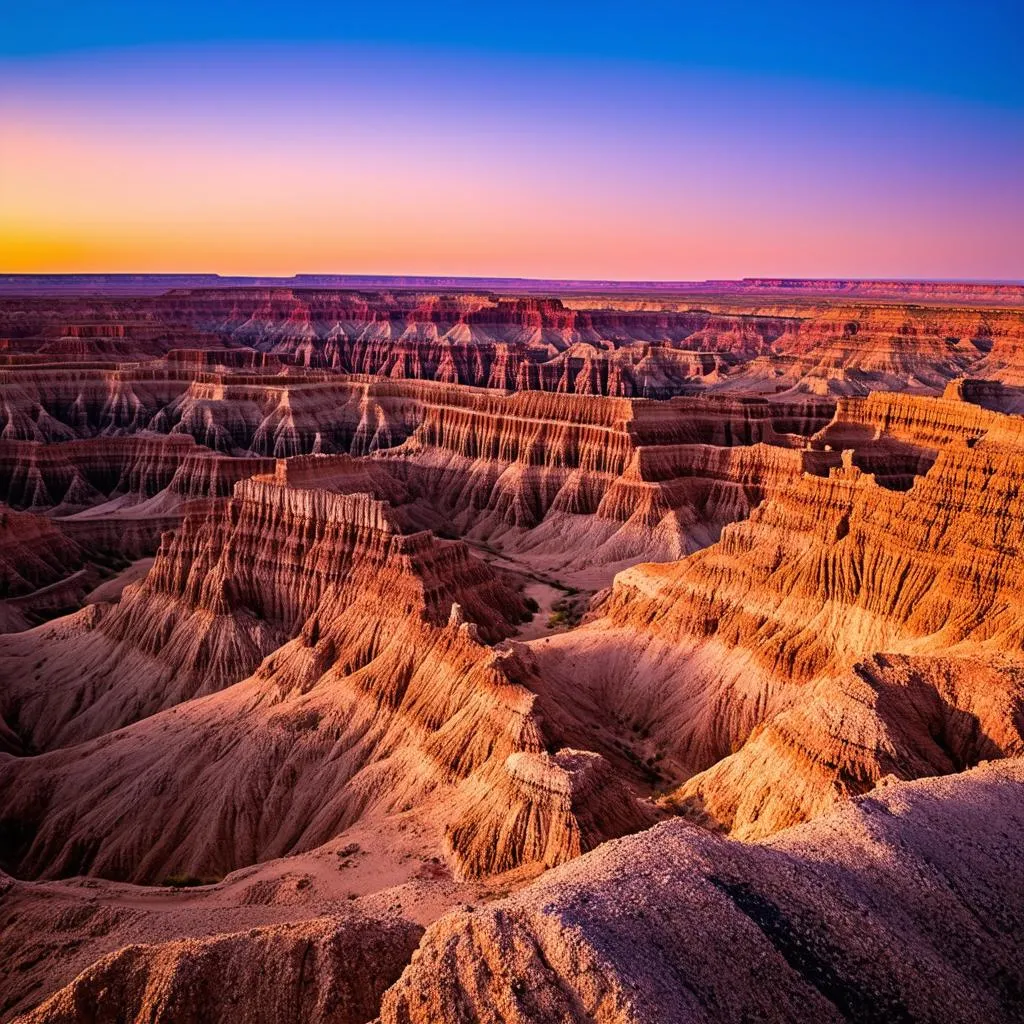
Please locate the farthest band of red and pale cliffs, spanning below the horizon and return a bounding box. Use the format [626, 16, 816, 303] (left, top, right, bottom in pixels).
[8, 283, 1024, 398]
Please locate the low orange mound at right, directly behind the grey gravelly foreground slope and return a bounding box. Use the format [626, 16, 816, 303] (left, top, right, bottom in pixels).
[668, 654, 1024, 839]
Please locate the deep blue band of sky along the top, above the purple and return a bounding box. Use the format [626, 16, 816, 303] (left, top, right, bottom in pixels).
[8, 0, 1024, 110]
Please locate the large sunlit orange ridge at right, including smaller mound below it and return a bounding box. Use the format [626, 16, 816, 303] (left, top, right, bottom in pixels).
[538, 387, 1024, 835]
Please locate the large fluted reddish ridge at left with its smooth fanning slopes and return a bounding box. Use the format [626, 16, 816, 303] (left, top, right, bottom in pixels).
[0, 459, 651, 881]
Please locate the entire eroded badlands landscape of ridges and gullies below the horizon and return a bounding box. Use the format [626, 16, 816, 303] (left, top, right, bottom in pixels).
[0, 283, 1024, 1024]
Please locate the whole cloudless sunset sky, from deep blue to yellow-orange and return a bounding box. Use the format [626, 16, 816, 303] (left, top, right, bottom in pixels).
[0, 0, 1024, 281]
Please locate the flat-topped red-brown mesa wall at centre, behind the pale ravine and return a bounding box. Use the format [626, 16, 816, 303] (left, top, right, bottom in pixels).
[364, 386, 838, 569]
